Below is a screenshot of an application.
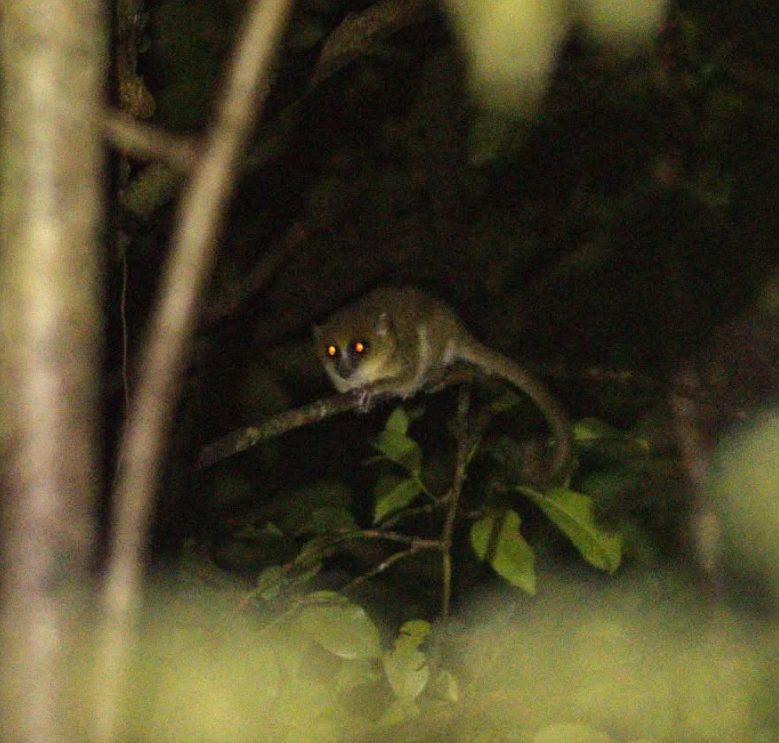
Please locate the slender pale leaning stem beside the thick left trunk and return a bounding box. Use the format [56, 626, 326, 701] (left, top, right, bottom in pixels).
[96, 0, 292, 741]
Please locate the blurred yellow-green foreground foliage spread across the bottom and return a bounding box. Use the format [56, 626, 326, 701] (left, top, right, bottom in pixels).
[155, 548, 769, 742]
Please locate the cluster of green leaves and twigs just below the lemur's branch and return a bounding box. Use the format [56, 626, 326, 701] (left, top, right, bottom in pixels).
[204, 400, 648, 628]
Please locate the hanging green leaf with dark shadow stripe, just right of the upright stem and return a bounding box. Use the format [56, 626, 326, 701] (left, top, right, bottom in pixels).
[471, 510, 536, 594]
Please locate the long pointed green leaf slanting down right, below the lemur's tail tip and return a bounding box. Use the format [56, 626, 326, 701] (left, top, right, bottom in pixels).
[518, 487, 622, 573]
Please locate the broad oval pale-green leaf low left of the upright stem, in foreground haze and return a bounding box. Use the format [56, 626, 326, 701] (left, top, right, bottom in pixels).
[297, 603, 381, 660]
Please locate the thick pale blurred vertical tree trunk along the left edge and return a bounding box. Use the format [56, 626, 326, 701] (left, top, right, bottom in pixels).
[0, 0, 106, 743]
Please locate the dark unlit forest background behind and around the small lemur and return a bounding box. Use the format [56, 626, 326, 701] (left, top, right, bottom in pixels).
[112, 0, 779, 604]
